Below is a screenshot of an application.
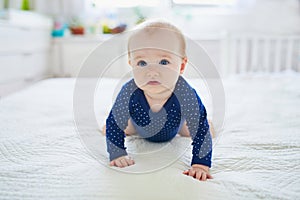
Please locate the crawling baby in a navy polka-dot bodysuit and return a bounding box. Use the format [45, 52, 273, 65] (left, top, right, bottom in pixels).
[105, 21, 212, 181]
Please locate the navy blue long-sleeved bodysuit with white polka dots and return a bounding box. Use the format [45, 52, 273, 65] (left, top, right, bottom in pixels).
[106, 76, 212, 167]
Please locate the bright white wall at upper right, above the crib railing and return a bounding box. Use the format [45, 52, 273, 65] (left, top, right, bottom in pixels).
[166, 0, 300, 38]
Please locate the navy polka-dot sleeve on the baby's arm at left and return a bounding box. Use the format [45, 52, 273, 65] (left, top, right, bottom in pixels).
[106, 81, 136, 160]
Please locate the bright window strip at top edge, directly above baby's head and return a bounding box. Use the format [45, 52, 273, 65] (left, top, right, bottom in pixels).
[93, 0, 159, 7]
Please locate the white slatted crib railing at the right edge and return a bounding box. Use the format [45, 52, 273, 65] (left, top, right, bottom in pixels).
[221, 34, 300, 75]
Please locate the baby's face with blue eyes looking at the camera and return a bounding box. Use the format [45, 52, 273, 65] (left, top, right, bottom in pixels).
[129, 30, 186, 94]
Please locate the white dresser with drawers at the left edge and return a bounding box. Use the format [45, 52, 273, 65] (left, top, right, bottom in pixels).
[0, 10, 52, 96]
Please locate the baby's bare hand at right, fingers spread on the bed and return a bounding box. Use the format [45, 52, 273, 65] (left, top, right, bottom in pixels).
[183, 164, 213, 181]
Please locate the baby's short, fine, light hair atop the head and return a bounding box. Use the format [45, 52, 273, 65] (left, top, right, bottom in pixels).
[127, 19, 186, 57]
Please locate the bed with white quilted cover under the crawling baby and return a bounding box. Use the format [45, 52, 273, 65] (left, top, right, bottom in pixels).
[0, 74, 300, 200]
